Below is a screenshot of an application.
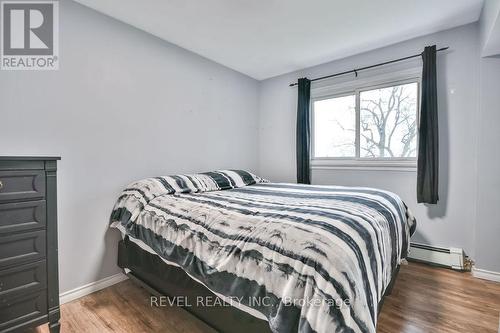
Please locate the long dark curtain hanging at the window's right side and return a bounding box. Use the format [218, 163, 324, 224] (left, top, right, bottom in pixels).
[417, 45, 439, 204]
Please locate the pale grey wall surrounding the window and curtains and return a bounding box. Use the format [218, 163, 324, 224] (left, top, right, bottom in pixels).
[259, 24, 479, 257]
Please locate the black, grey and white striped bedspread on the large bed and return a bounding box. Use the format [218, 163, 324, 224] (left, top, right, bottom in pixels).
[111, 170, 415, 333]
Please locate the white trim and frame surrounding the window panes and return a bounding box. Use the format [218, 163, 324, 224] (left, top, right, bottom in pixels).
[310, 67, 422, 172]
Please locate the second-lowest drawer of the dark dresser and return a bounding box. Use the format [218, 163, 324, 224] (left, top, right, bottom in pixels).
[0, 260, 47, 299]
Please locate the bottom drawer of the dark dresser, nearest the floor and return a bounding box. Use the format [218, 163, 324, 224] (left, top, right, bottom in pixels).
[0, 290, 47, 332]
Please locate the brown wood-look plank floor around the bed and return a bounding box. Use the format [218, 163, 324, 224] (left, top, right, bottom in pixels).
[31, 263, 500, 333]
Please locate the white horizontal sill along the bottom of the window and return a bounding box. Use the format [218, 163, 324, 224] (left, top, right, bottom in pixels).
[311, 158, 417, 172]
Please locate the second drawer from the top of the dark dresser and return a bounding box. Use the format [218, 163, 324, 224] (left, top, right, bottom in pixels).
[0, 200, 46, 235]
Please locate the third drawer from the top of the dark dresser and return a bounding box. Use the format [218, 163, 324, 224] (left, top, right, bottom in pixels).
[0, 230, 46, 269]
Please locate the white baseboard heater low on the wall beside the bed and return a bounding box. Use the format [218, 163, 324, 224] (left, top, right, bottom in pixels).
[408, 243, 466, 271]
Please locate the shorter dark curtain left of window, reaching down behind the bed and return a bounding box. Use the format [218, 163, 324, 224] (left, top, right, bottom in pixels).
[296, 78, 311, 184]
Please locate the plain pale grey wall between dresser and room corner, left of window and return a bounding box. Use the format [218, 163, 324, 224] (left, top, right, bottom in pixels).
[0, 1, 258, 292]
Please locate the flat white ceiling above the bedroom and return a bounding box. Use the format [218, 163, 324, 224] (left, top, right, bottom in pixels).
[72, 0, 483, 80]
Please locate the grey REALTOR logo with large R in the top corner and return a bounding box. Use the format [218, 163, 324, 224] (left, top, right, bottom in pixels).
[0, 1, 59, 70]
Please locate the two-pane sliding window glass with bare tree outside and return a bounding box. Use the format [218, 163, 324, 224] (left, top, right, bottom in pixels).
[312, 79, 419, 166]
